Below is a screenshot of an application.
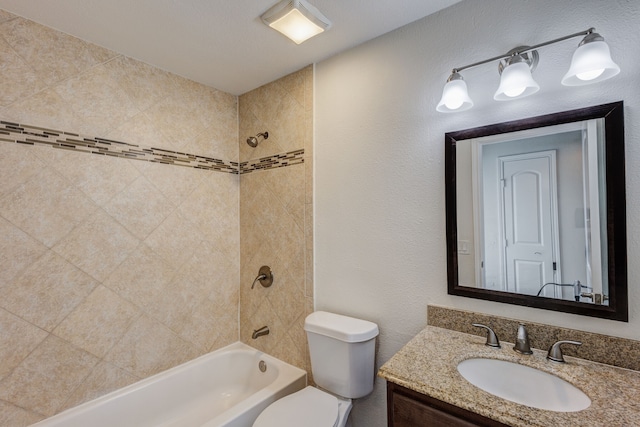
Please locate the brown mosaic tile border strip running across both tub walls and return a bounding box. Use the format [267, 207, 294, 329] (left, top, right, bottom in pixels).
[0, 120, 304, 174]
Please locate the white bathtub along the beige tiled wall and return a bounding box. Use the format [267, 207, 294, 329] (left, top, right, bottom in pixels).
[32, 342, 307, 427]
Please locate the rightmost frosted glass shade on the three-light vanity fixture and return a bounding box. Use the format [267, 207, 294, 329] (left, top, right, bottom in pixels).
[562, 40, 620, 86]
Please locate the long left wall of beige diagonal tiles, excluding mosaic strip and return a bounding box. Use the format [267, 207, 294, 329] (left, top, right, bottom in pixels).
[0, 11, 240, 426]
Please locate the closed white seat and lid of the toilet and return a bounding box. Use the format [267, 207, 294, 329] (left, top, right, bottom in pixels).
[253, 386, 339, 427]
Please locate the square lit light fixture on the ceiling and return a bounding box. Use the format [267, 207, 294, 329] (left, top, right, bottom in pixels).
[260, 0, 331, 44]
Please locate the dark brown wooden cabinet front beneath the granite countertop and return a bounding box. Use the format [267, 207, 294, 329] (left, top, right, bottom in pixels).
[387, 381, 506, 427]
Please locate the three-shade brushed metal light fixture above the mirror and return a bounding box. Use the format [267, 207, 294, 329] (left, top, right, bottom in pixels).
[436, 28, 620, 113]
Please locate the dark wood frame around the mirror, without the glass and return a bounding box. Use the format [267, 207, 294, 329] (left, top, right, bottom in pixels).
[445, 101, 629, 322]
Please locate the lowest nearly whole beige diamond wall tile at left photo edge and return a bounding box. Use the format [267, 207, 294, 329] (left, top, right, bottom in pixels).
[0, 335, 99, 416]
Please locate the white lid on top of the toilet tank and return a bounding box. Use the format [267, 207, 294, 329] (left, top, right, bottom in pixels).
[304, 311, 378, 342]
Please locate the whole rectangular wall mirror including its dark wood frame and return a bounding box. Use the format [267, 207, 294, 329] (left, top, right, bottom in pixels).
[445, 102, 628, 321]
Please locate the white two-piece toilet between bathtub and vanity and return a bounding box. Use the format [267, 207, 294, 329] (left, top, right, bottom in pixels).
[253, 311, 378, 427]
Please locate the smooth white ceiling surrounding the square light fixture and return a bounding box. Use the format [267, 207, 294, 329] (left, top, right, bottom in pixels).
[0, 0, 460, 95]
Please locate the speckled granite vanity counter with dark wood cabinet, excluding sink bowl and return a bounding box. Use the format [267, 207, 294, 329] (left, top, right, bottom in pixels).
[378, 326, 640, 427]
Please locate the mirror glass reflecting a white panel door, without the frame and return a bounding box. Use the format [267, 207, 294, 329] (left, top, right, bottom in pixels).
[456, 119, 609, 305]
